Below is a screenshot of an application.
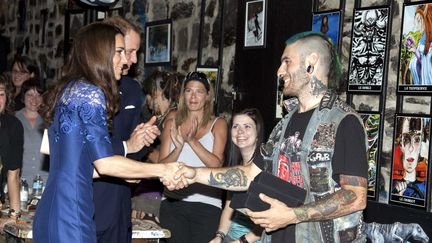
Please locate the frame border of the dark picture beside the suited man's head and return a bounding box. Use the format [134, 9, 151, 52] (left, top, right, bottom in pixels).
[144, 19, 173, 66]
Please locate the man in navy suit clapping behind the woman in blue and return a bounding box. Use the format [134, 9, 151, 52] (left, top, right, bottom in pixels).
[93, 16, 160, 243]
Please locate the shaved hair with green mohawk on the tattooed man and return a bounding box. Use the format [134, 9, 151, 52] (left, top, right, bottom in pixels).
[285, 31, 342, 89]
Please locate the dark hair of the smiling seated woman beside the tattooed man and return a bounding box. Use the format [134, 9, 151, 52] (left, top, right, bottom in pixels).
[225, 108, 264, 166]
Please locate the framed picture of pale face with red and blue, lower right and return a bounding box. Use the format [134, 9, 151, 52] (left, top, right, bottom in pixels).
[390, 114, 431, 209]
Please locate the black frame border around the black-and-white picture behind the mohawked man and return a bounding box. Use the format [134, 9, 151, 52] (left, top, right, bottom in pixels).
[347, 5, 392, 94]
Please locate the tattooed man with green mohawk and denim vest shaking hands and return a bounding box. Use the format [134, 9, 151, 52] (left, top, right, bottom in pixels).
[170, 32, 368, 243]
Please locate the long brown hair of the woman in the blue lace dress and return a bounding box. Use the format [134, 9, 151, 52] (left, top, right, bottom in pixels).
[41, 22, 123, 129]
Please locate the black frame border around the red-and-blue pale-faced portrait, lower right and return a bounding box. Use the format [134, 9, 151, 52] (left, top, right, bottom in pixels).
[388, 113, 432, 211]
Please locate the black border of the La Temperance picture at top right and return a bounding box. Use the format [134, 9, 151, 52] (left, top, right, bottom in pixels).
[396, 0, 432, 96]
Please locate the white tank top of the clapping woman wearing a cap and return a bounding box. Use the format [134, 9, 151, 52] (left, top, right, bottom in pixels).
[163, 117, 222, 208]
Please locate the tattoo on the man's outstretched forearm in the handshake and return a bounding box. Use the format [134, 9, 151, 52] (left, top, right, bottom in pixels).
[208, 168, 248, 188]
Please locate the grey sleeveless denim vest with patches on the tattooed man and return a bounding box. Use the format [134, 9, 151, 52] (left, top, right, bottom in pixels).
[261, 90, 367, 243]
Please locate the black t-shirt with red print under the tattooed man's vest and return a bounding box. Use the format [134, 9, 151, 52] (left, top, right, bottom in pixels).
[254, 110, 368, 243]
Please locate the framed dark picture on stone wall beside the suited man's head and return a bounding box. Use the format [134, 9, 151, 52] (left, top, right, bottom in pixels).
[145, 19, 172, 66]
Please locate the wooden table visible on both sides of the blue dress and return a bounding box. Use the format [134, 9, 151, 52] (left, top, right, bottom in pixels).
[4, 214, 171, 243]
